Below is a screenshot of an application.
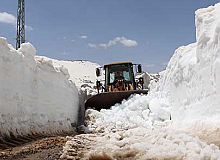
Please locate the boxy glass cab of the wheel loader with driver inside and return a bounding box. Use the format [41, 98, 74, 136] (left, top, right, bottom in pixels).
[104, 62, 136, 92]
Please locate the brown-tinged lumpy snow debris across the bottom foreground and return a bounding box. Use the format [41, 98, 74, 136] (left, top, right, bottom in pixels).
[61, 125, 220, 160]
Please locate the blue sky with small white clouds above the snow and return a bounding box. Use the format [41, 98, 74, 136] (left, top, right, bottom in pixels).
[0, 0, 219, 73]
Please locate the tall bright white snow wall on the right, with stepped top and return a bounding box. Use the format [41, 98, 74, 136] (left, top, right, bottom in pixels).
[155, 3, 220, 124]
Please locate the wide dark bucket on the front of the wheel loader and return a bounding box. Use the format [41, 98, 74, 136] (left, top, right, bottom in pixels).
[85, 90, 148, 111]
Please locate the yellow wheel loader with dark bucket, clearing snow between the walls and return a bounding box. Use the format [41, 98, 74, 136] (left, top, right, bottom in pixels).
[85, 62, 148, 111]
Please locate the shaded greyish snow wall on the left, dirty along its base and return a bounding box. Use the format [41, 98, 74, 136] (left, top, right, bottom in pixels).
[0, 37, 79, 137]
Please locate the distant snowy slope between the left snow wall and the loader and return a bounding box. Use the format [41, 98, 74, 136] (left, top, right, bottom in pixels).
[36, 56, 104, 95]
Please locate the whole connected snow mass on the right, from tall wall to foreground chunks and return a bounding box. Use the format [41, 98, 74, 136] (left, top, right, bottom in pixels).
[61, 3, 220, 160]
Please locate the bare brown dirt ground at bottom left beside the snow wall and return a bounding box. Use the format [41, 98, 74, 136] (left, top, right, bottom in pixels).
[0, 136, 75, 160]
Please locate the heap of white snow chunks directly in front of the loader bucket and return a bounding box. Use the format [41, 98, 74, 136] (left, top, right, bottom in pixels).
[86, 95, 170, 133]
